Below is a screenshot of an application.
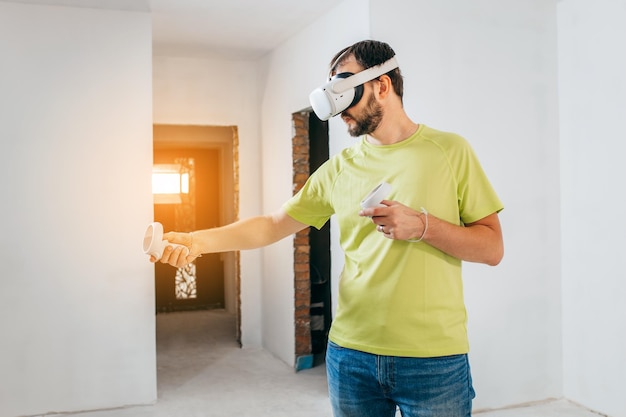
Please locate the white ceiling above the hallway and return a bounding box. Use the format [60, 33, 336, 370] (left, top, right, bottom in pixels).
[0, 0, 340, 59]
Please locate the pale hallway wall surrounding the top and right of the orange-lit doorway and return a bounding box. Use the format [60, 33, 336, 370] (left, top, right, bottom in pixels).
[154, 56, 262, 347]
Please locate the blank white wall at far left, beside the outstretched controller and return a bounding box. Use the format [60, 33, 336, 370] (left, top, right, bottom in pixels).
[0, 2, 156, 417]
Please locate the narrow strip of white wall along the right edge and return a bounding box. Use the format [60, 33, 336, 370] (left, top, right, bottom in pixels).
[559, 0, 626, 417]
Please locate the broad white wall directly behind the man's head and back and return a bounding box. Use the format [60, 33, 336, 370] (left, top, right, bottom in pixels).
[371, 0, 562, 409]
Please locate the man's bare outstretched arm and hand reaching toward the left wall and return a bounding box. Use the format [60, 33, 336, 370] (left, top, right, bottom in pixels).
[154, 209, 308, 267]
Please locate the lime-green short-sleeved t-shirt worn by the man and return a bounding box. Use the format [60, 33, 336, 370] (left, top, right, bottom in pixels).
[283, 125, 503, 357]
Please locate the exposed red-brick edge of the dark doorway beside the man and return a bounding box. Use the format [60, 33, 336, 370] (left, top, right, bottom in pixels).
[292, 112, 312, 357]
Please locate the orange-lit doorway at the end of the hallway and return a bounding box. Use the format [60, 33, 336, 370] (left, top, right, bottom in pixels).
[153, 125, 241, 341]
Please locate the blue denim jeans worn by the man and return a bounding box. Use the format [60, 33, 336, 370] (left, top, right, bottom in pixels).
[326, 342, 475, 417]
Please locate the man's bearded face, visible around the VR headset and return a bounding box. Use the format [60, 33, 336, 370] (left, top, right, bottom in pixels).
[337, 56, 384, 137]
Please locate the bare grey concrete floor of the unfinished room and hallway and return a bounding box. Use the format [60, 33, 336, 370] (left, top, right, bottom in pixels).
[46, 310, 598, 417]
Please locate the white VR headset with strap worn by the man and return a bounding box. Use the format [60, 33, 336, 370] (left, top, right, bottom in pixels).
[309, 56, 398, 121]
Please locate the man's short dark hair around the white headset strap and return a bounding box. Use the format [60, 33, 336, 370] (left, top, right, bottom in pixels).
[330, 40, 404, 100]
